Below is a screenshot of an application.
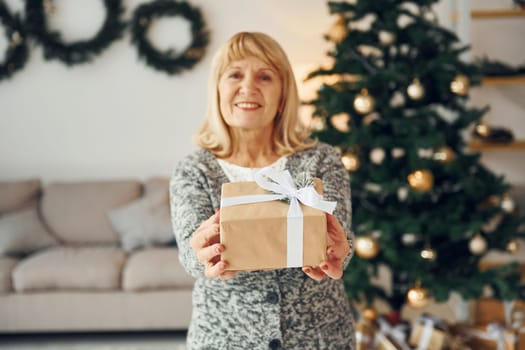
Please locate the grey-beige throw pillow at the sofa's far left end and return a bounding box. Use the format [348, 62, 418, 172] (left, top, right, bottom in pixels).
[0, 207, 58, 255]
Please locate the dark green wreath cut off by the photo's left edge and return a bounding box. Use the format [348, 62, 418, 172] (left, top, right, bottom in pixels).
[0, 0, 29, 80]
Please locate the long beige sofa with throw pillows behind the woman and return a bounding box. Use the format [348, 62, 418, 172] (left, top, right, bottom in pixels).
[0, 178, 194, 333]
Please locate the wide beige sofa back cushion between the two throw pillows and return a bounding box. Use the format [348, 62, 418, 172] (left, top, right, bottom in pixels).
[42, 181, 142, 243]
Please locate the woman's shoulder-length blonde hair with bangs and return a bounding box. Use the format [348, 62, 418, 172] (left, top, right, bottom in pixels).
[195, 32, 315, 158]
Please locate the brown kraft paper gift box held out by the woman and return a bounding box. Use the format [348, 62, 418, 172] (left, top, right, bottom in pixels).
[220, 168, 335, 271]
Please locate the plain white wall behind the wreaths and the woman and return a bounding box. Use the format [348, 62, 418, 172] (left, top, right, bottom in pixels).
[4, 0, 516, 186]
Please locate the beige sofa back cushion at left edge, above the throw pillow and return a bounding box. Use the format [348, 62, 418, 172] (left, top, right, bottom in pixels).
[0, 179, 41, 213]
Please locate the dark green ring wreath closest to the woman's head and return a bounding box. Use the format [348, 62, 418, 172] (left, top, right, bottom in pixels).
[131, 0, 209, 74]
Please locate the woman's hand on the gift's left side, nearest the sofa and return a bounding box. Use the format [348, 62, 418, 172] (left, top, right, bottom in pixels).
[190, 211, 235, 280]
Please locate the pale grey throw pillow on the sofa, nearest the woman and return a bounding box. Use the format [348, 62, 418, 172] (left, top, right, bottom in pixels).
[108, 179, 175, 252]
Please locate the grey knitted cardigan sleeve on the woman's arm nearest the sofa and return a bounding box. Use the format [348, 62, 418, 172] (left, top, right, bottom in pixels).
[170, 155, 215, 278]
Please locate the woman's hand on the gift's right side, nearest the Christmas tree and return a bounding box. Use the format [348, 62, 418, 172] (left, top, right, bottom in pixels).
[303, 214, 350, 281]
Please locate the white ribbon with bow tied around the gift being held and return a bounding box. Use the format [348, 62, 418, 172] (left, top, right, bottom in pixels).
[221, 167, 337, 267]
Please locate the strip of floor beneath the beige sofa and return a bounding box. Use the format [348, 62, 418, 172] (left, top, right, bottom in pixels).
[0, 332, 186, 350]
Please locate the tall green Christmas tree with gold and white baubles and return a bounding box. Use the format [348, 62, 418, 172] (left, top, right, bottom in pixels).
[307, 0, 525, 311]
